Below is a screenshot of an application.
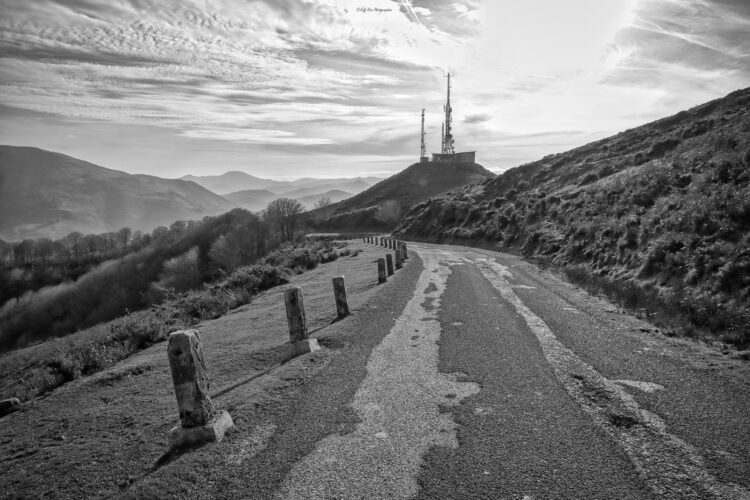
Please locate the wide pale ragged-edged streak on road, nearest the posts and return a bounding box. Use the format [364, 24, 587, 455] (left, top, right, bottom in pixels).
[277, 251, 479, 499]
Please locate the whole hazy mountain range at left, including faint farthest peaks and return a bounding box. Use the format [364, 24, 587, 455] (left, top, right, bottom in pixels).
[0, 146, 380, 241]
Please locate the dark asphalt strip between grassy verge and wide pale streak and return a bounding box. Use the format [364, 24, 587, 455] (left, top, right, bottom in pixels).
[204, 255, 422, 499]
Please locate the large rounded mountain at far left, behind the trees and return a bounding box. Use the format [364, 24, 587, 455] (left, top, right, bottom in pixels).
[0, 146, 236, 241]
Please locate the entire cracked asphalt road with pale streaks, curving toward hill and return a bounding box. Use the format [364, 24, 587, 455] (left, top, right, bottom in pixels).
[229, 240, 750, 499]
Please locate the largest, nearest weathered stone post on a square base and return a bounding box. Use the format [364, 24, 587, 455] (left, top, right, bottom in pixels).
[167, 330, 234, 448]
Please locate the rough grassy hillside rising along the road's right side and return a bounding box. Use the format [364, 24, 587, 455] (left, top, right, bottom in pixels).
[397, 89, 750, 346]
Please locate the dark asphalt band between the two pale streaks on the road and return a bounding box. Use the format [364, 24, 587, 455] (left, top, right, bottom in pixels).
[419, 265, 651, 499]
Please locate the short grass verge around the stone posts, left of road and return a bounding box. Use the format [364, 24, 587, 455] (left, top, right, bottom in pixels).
[0, 243, 406, 498]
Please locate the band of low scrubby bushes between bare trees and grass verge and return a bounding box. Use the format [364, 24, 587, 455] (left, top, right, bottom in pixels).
[0, 240, 355, 401]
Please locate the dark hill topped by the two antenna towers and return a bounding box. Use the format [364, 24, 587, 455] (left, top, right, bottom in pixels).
[310, 161, 495, 230]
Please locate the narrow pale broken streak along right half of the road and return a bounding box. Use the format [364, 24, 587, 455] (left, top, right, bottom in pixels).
[476, 254, 750, 499]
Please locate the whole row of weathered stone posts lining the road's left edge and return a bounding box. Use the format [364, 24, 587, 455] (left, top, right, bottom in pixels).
[167, 236, 409, 449]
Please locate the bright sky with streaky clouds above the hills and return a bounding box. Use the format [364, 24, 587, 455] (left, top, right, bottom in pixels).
[0, 0, 750, 179]
